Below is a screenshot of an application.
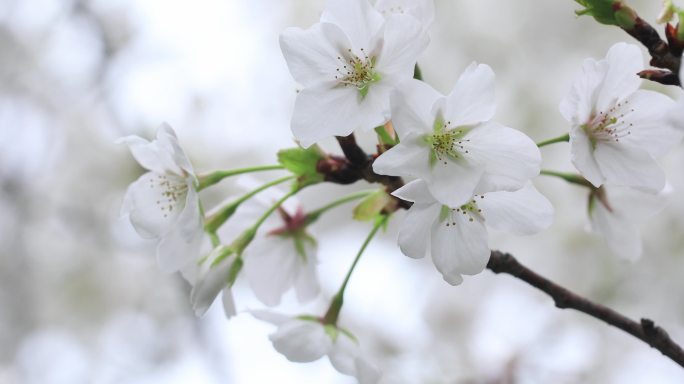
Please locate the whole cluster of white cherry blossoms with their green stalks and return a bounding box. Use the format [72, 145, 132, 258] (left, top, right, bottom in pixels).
[116, 0, 684, 383]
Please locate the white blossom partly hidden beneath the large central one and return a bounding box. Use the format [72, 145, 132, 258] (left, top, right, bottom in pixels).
[393, 180, 553, 285]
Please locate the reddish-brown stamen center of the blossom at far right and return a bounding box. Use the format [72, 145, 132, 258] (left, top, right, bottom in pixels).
[582, 100, 634, 146]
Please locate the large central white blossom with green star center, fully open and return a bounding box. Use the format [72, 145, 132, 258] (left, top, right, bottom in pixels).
[373, 67, 541, 207]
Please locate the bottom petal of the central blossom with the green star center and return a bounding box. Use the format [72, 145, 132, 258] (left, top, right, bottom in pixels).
[425, 160, 484, 207]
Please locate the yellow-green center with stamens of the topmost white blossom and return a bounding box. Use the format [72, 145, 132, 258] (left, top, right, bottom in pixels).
[335, 48, 380, 98]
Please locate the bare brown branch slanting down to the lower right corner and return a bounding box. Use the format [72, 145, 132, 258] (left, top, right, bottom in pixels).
[487, 251, 684, 367]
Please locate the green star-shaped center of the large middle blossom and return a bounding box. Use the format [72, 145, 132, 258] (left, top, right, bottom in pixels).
[425, 119, 470, 165]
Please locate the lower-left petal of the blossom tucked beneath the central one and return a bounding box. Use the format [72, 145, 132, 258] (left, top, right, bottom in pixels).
[398, 204, 441, 259]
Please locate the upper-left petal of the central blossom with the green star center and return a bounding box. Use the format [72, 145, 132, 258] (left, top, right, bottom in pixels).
[390, 79, 444, 141]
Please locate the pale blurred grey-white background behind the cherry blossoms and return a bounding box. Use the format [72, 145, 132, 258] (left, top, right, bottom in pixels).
[0, 0, 684, 384]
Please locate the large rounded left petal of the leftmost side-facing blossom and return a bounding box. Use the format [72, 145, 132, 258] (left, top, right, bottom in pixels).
[124, 172, 186, 238]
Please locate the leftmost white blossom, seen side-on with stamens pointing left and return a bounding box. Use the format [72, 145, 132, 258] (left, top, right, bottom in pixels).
[118, 124, 204, 272]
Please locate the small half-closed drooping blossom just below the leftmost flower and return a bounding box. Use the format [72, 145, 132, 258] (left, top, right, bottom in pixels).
[182, 245, 237, 318]
